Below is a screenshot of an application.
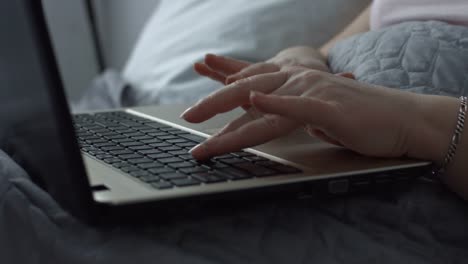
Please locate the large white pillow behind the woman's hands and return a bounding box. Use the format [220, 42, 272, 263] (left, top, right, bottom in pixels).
[123, 0, 369, 105]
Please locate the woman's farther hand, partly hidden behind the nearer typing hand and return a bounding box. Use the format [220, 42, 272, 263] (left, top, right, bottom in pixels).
[194, 47, 329, 84]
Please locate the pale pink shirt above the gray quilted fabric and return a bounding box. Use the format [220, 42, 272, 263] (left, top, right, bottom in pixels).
[370, 0, 468, 29]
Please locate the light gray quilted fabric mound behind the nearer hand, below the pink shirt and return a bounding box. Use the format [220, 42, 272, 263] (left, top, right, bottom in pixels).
[329, 21, 468, 97]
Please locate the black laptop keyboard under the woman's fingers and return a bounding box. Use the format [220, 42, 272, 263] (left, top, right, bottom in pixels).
[73, 111, 301, 189]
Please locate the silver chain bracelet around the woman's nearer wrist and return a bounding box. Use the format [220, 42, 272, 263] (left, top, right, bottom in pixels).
[432, 96, 468, 177]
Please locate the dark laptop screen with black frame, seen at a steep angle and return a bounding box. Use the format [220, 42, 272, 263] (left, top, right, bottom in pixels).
[0, 0, 92, 221]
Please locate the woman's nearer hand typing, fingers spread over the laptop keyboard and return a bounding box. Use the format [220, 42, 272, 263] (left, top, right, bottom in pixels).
[182, 67, 456, 163]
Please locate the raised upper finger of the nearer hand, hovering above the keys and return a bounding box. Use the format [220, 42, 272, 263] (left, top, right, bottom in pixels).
[181, 72, 287, 123]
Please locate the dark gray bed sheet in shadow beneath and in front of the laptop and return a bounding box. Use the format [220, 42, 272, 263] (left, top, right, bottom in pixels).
[0, 148, 468, 264]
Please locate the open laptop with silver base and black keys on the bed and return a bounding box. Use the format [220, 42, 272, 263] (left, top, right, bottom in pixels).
[0, 0, 429, 224]
